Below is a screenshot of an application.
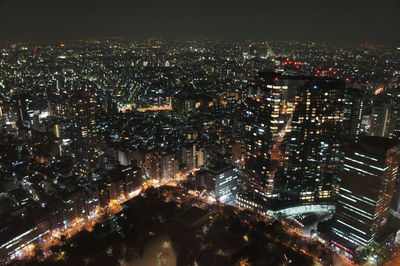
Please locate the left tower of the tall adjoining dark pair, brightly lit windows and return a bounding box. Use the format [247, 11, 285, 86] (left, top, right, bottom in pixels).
[244, 71, 293, 197]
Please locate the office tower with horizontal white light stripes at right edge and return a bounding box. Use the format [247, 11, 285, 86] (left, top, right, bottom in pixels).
[332, 136, 400, 251]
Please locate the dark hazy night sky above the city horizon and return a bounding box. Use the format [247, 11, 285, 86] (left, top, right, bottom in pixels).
[0, 0, 400, 43]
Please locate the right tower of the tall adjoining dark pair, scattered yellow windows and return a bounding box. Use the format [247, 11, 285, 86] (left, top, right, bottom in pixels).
[277, 79, 344, 202]
